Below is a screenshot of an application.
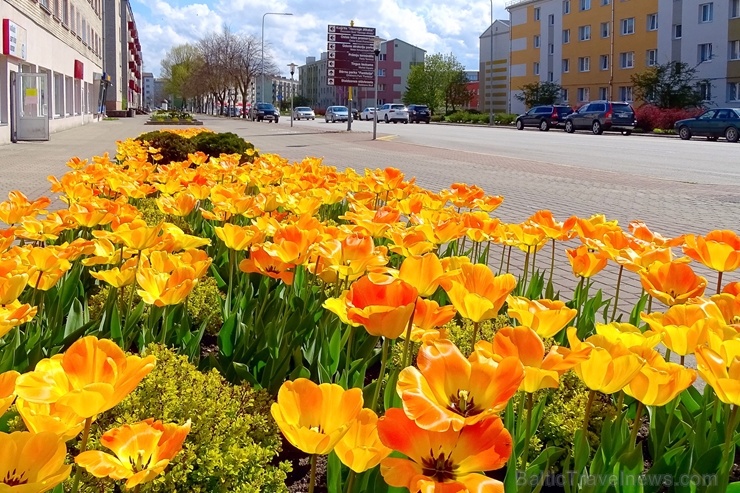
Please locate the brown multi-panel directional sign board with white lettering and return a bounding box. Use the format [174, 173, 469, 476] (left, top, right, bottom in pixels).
[326, 25, 375, 87]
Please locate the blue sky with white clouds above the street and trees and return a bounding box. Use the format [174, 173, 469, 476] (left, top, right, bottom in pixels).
[131, 0, 509, 77]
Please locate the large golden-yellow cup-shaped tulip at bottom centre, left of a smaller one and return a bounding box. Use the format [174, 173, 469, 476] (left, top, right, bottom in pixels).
[270, 378, 362, 455]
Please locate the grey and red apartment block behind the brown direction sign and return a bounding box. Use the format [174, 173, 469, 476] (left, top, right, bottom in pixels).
[298, 39, 426, 109]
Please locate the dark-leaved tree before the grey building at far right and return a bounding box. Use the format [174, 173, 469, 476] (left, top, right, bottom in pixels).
[631, 62, 709, 109]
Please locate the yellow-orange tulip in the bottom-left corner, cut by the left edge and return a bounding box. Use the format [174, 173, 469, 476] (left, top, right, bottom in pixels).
[0, 431, 72, 493]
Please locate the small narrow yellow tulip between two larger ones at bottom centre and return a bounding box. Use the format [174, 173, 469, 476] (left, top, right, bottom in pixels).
[334, 409, 392, 473]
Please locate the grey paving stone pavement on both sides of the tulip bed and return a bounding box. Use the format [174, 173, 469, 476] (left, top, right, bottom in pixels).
[0, 116, 740, 316]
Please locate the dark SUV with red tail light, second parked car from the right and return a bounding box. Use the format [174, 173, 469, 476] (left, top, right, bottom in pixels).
[565, 101, 637, 135]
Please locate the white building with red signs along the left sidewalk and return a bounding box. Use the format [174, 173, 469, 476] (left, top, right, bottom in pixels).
[0, 0, 103, 144]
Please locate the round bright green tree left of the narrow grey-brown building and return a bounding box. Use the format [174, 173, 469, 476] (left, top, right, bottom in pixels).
[402, 53, 471, 112]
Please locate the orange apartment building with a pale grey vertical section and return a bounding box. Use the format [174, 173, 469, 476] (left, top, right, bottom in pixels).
[507, 0, 661, 113]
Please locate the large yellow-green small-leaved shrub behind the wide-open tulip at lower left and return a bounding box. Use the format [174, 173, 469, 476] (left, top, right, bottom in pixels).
[68, 346, 290, 493]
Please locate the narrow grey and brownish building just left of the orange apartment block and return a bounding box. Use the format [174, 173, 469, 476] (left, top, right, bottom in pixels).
[478, 19, 511, 113]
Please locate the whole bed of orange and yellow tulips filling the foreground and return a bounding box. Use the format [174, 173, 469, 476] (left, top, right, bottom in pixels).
[0, 129, 740, 492]
